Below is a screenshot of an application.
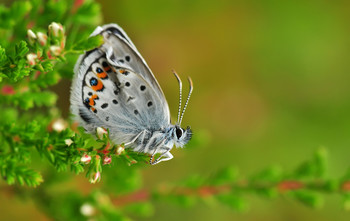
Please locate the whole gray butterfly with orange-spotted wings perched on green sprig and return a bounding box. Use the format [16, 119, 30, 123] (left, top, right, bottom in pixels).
[70, 24, 193, 165]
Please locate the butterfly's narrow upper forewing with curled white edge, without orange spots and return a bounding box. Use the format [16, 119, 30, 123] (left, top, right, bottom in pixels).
[92, 24, 170, 122]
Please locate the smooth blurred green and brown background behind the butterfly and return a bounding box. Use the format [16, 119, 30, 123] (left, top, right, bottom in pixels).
[0, 0, 350, 221]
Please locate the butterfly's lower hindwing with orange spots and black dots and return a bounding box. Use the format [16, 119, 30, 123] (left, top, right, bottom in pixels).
[71, 48, 169, 143]
